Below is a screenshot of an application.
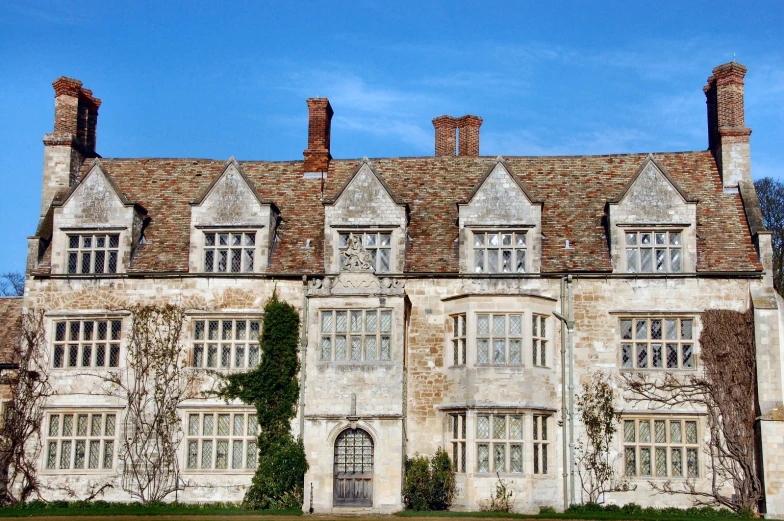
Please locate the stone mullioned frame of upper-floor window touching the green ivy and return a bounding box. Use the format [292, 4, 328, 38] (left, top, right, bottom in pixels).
[188, 313, 264, 373]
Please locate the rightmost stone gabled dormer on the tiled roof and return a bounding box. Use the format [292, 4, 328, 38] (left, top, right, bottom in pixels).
[608, 155, 697, 273]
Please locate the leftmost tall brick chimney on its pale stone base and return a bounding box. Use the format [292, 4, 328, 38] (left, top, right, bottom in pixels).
[41, 76, 101, 217]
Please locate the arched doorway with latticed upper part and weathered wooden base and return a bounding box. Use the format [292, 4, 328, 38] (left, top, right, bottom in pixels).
[333, 429, 373, 507]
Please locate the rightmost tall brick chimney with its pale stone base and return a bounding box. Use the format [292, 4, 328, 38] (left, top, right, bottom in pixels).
[702, 62, 751, 192]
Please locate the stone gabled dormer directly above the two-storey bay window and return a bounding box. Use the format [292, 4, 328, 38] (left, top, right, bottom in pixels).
[457, 156, 542, 273]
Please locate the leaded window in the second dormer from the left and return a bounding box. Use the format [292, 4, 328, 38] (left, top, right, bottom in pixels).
[204, 231, 256, 273]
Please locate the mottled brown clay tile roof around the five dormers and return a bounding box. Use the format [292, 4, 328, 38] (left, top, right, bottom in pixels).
[44, 151, 762, 274]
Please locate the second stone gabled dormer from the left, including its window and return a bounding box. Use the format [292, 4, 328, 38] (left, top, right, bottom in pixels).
[189, 157, 280, 273]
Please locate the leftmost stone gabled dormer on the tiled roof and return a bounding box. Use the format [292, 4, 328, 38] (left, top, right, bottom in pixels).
[51, 159, 147, 275]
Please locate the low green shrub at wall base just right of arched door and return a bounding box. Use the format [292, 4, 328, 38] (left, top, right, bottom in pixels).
[403, 447, 455, 510]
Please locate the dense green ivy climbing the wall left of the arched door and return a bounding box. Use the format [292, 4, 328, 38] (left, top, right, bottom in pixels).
[217, 293, 308, 509]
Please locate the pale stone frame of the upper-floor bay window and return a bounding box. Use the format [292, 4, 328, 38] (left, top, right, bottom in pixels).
[441, 294, 557, 371]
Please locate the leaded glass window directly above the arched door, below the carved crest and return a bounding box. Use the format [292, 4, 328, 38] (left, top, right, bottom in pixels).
[319, 309, 392, 363]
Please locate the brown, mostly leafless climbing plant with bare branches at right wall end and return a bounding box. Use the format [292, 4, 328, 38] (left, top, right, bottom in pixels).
[624, 309, 763, 512]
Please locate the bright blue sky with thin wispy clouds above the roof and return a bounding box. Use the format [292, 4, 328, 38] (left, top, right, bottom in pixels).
[0, 0, 784, 273]
